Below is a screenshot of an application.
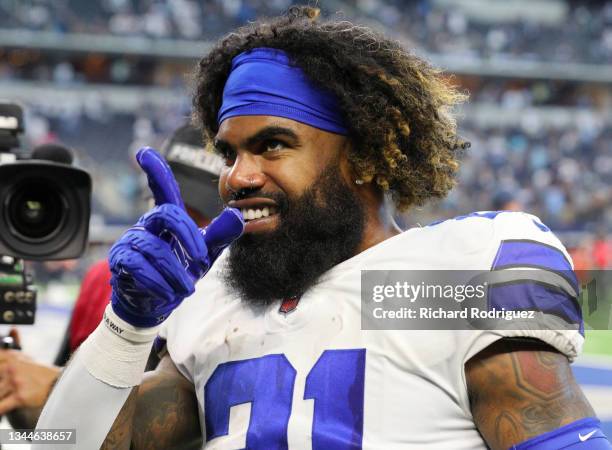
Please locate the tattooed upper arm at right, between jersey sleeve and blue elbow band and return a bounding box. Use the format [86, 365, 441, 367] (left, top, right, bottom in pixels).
[465, 338, 595, 449]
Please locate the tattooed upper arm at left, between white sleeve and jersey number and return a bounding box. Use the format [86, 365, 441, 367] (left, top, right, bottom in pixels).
[101, 355, 202, 450]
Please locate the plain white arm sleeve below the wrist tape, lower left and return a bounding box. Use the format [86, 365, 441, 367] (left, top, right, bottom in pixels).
[31, 352, 133, 450]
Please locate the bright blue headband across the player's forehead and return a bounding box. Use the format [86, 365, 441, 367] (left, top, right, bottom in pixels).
[217, 47, 348, 135]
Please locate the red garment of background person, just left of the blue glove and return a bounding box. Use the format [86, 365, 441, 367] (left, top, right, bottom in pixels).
[70, 260, 111, 353]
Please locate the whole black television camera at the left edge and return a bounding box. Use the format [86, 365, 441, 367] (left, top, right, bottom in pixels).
[0, 101, 91, 324]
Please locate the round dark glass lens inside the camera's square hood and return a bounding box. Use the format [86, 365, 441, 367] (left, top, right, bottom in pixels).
[6, 181, 66, 240]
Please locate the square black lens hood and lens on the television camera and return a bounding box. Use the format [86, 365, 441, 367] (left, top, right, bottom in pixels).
[0, 160, 91, 260]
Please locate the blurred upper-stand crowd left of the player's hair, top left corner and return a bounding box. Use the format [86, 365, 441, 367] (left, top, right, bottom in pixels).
[0, 0, 292, 39]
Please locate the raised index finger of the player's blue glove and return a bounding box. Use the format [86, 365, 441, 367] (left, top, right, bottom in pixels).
[136, 147, 185, 210]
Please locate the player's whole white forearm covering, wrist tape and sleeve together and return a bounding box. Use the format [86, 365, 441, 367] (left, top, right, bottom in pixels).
[32, 304, 159, 450]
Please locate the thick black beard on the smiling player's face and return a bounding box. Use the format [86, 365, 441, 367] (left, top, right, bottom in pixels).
[224, 163, 365, 306]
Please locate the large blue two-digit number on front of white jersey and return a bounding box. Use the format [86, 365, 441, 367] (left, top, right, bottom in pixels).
[204, 349, 365, 450]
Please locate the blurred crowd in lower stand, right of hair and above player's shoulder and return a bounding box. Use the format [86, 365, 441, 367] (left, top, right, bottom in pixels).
[436, 121, 612, 232]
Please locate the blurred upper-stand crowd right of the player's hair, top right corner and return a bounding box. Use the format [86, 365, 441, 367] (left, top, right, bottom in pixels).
[354, 0, 612, 64]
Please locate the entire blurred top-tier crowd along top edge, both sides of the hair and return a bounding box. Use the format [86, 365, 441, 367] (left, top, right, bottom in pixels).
[0, 0, 612, 63]
